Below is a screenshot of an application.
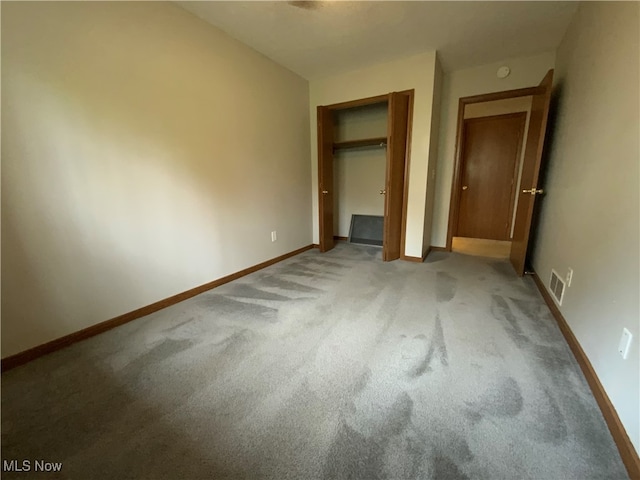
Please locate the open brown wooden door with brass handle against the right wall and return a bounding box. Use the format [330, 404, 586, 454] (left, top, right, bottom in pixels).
[510, 70, 553, 276]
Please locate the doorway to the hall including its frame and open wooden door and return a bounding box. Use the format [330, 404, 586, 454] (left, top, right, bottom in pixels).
[446, 70, 553, 275]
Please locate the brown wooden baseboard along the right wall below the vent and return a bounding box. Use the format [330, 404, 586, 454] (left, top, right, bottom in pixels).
[533, 273, 640, 480]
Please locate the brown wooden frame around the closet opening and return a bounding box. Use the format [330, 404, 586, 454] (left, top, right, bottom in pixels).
[316, 89, 415, 260]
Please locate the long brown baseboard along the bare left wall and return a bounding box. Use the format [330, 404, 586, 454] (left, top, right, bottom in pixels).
[0, 245, 314, 372]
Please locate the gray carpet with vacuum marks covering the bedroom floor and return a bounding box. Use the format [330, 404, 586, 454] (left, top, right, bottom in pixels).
[2, 243, 627, 480]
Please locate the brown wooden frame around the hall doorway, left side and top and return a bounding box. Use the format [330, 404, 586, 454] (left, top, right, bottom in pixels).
[445, 86, 540, 252]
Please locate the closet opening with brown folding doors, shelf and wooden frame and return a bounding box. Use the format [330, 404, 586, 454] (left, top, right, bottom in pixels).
[318, 90, 413, 261]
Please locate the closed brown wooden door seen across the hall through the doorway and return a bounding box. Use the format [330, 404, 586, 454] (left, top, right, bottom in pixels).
[455, 112, 527, 240]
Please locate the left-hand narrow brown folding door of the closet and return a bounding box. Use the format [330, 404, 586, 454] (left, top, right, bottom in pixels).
[318, 107, 335, 252]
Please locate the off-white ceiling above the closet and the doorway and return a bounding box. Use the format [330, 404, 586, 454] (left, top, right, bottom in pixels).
[178, 0, 577, 79]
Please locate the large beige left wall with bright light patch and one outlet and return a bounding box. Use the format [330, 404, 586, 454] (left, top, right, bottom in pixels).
[2, 2, 311, 357]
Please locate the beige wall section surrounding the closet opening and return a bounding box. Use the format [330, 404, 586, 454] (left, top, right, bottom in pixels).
[309, 52, 436, 257]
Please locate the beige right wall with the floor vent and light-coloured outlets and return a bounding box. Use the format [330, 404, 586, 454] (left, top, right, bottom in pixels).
[533, 2, 640, 451]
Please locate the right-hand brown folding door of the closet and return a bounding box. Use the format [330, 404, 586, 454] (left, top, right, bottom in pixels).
[382, 92, 409, 262]
